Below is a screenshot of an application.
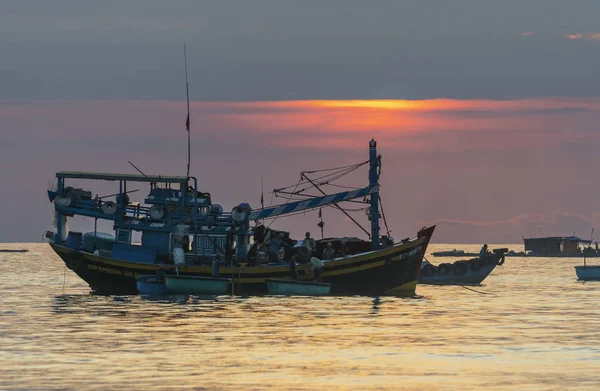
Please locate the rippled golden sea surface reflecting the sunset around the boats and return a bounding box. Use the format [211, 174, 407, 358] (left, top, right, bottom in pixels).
[0, 244, 600, 390]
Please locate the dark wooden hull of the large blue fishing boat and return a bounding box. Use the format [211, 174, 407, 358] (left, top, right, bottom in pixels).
[50, 226, 435, 296]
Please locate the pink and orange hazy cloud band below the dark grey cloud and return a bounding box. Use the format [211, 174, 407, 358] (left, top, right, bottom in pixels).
[0, 98, 600, 243]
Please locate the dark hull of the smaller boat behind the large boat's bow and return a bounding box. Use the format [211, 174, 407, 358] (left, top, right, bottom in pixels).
[419, 254, 502, 285]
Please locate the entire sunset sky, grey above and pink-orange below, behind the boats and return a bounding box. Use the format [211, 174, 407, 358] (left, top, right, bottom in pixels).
[0, 0, 600, 243]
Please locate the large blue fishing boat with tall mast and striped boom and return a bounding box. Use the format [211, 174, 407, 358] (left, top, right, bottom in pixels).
[46, 140, 435, 296]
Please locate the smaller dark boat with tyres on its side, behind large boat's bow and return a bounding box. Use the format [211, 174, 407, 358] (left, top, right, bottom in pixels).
[419, 248, 508, 285]
